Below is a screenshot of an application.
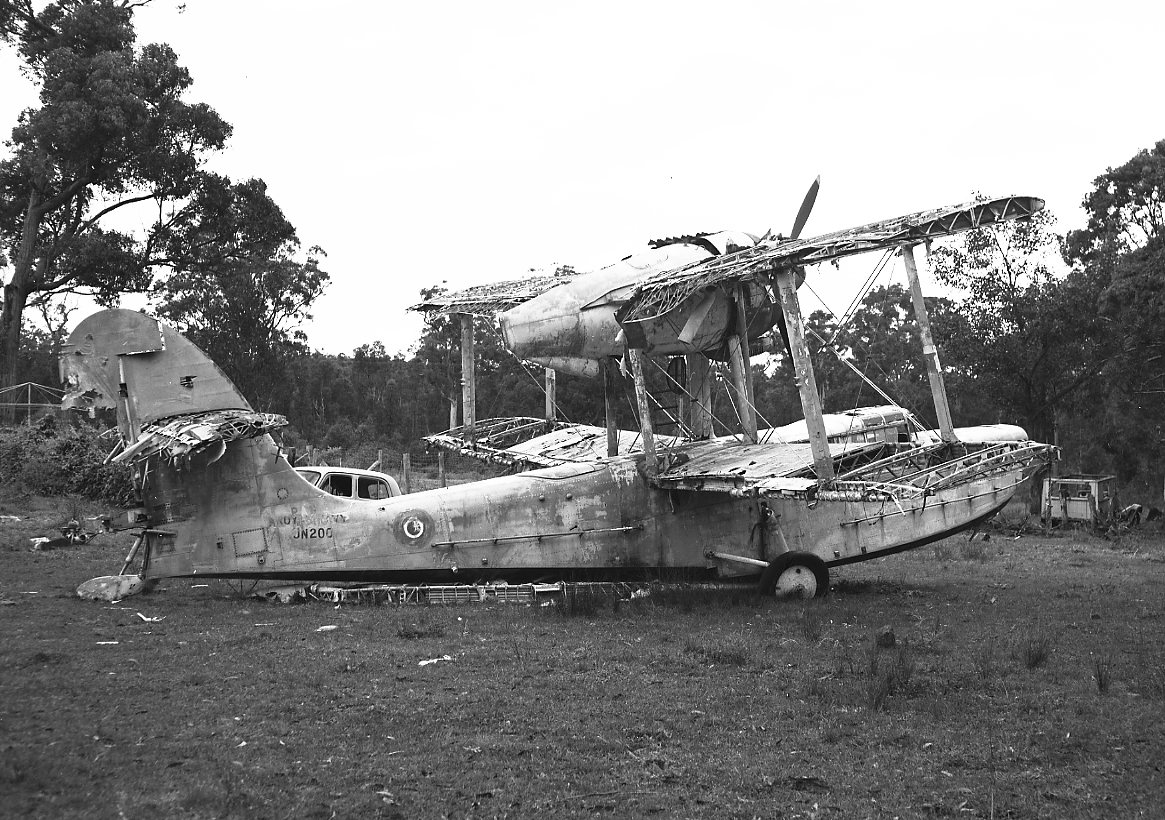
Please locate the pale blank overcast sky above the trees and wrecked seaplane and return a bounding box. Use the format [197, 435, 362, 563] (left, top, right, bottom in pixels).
[0, 0, 1165, 353]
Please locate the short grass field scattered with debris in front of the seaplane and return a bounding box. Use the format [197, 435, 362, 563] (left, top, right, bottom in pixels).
[0, 504, 1165, 818]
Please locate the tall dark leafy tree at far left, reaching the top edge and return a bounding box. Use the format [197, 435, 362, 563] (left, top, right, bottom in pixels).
[0, 0, 231, 380]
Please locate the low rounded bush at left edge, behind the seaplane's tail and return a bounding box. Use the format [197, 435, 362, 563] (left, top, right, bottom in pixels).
[0, 416, 135, 504]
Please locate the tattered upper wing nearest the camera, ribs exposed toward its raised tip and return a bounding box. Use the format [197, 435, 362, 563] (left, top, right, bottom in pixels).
[617, 197, 1044, 323]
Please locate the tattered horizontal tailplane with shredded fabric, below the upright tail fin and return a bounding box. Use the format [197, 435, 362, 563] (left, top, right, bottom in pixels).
[111, 410, 288, 469]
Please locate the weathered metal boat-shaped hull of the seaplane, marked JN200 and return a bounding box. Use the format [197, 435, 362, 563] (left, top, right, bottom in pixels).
[138, 436, 1022, 580]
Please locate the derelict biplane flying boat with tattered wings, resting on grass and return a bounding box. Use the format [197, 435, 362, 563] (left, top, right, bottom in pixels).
[61, 185, 1053, 596]
